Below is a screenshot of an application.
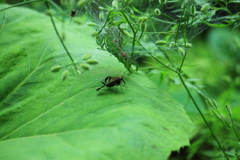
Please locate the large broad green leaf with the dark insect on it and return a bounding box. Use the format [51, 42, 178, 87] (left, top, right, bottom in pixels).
[0, 5, 194, 160]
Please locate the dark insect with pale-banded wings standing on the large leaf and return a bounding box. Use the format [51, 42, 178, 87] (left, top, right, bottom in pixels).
[97, 76, 126, 91]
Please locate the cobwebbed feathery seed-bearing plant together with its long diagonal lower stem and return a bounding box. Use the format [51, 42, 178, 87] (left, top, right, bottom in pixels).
[86, 1, 240, 159]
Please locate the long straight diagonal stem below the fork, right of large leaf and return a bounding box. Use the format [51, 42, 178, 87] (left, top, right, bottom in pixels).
[178, 73, 229, 160]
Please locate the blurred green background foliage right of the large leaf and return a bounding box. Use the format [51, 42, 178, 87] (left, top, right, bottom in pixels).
[166, 29, 240, 159]
